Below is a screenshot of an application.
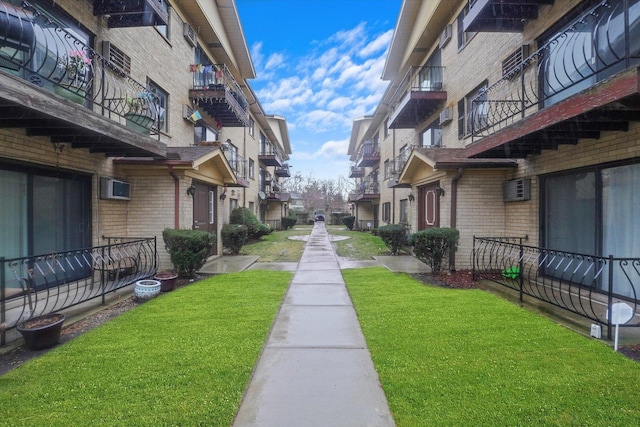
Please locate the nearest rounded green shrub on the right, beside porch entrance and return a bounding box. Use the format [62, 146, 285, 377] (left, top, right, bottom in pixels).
[409, 228, 460, 274]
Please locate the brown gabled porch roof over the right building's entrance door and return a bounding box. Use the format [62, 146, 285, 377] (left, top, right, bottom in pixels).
[398, 148, 518, 185]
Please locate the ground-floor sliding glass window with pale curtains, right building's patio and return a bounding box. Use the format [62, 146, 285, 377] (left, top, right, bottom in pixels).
[542, 163, 640, 296]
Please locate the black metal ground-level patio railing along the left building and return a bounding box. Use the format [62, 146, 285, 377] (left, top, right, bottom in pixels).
[0, 237, 157, 345]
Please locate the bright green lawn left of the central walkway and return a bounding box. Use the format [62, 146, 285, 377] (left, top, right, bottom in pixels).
[0, 270, 291, 426]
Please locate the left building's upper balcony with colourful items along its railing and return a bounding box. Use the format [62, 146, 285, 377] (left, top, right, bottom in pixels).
[189, 64, 249, 127]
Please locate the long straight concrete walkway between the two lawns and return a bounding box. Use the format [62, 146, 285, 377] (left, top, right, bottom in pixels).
[233, 222, 395, 427]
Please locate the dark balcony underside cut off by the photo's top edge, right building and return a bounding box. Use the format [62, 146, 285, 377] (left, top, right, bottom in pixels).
[463, 0, 554, 33]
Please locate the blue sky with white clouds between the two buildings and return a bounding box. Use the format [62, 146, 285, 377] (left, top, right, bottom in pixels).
[236, 0, 401, 179]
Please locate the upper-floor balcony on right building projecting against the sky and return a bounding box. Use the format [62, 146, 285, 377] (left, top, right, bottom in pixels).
[389, 66, 447, 129]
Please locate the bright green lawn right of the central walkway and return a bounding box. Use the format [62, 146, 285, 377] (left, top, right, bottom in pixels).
[343, 268, 640, 426]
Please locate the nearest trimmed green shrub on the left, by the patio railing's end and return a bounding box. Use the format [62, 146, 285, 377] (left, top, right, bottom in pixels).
[162, 228, 216, 277]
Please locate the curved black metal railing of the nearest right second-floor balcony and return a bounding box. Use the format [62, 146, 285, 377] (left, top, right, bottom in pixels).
[468, 0, 640, 139]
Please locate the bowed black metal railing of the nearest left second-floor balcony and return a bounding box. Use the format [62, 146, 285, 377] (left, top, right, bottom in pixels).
[0, 2, 164, 139]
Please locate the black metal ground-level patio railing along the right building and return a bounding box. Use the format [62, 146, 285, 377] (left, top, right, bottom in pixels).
[472, 237, 640, 338]
